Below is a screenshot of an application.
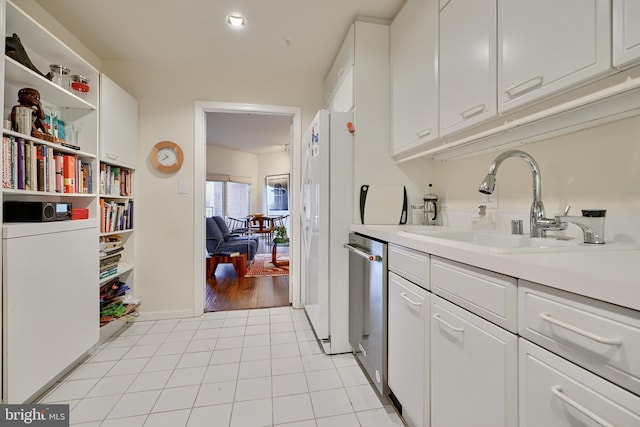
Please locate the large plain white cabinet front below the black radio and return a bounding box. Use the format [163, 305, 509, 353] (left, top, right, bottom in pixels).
[2, 226, 99, 403]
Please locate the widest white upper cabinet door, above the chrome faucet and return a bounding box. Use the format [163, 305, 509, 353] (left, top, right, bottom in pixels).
[498, 0, 612, 112]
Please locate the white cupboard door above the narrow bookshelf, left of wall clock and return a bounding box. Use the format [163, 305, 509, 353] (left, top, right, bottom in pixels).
[100, 74, 138, 169]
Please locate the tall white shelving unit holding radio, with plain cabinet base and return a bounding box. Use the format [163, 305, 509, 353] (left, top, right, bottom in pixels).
[0, 0, 100, 403]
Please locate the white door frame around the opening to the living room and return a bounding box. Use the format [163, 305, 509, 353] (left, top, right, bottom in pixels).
[193, 101, 302, 316]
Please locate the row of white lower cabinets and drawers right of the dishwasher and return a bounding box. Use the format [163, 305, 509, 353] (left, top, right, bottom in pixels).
[388, 243, 640, 427]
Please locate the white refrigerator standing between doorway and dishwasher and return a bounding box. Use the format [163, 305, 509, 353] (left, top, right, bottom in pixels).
[300, 110, 354, 354]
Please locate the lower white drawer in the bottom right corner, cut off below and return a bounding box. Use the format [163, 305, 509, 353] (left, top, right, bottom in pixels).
[518, 339, 640, 427]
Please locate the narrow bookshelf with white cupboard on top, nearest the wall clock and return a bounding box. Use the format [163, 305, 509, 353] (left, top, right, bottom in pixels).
[98, 74, 140, 342]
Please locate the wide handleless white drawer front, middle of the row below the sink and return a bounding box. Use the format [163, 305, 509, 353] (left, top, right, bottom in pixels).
[431, 257, 518, 333]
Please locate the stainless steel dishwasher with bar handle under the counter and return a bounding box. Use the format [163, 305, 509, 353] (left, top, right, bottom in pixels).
[344, 233, 388, 396]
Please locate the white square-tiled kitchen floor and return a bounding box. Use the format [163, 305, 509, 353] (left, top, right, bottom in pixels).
[41, 307, 403, 427]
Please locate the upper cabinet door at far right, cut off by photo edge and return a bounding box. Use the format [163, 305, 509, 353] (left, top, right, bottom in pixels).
[613, 0, 640, 67]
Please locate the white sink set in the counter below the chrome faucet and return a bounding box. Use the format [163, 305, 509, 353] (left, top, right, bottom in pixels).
[398, 228, 638, 254]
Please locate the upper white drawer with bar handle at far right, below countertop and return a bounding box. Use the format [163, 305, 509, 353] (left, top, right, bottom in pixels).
[518, 280, 640, 394]
